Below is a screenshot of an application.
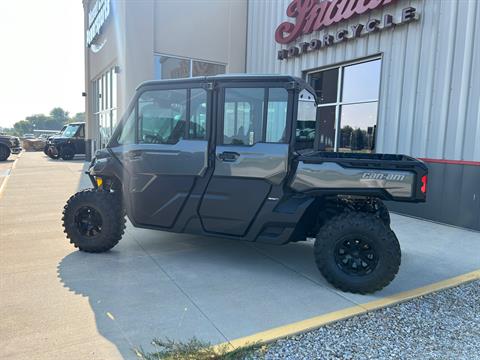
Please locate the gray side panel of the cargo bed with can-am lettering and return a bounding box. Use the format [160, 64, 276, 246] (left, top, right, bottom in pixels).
[290, 161, 415, 198]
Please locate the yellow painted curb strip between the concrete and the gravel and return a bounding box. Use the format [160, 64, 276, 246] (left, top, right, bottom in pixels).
[214, 270, 480, 350]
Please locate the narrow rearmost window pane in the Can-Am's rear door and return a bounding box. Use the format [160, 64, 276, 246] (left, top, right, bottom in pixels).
[265, 88, 288, 143]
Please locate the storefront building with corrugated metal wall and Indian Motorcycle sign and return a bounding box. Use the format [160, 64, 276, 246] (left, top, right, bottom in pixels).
[84, 0, 480, 230]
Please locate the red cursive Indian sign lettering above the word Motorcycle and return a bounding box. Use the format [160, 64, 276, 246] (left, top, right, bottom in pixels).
[275, 0, 397, 44]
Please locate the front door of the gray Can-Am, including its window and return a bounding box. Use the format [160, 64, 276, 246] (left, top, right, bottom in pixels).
[112, 84, 210, 228]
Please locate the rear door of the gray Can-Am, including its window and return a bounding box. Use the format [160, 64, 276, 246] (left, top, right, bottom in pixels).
[199, 82, 293, 236]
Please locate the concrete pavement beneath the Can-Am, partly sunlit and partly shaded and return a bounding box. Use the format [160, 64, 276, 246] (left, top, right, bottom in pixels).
[0, 153, 480, 360]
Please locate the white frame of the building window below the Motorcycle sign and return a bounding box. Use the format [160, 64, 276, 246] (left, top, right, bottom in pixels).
[304, 54, 383, 152]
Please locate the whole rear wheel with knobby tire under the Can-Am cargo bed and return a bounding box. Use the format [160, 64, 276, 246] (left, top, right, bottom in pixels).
[315, 212, 401, 294]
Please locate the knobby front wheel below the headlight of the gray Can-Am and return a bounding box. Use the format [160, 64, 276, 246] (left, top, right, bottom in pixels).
[62, 189, 125, 253]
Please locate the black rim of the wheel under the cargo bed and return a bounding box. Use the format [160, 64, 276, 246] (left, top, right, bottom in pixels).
[335, 236, 378, 276]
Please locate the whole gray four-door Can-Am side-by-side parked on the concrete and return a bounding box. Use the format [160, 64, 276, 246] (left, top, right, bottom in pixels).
[63, 75, 427, 293]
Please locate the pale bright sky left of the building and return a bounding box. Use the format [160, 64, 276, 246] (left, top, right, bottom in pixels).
[0, 0, 85, 127]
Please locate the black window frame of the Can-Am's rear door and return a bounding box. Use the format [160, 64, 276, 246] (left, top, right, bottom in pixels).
[215, 82, 294, 147]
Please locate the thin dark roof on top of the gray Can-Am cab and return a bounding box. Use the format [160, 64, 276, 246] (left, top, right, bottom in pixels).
[137, 74, 313, 90]
